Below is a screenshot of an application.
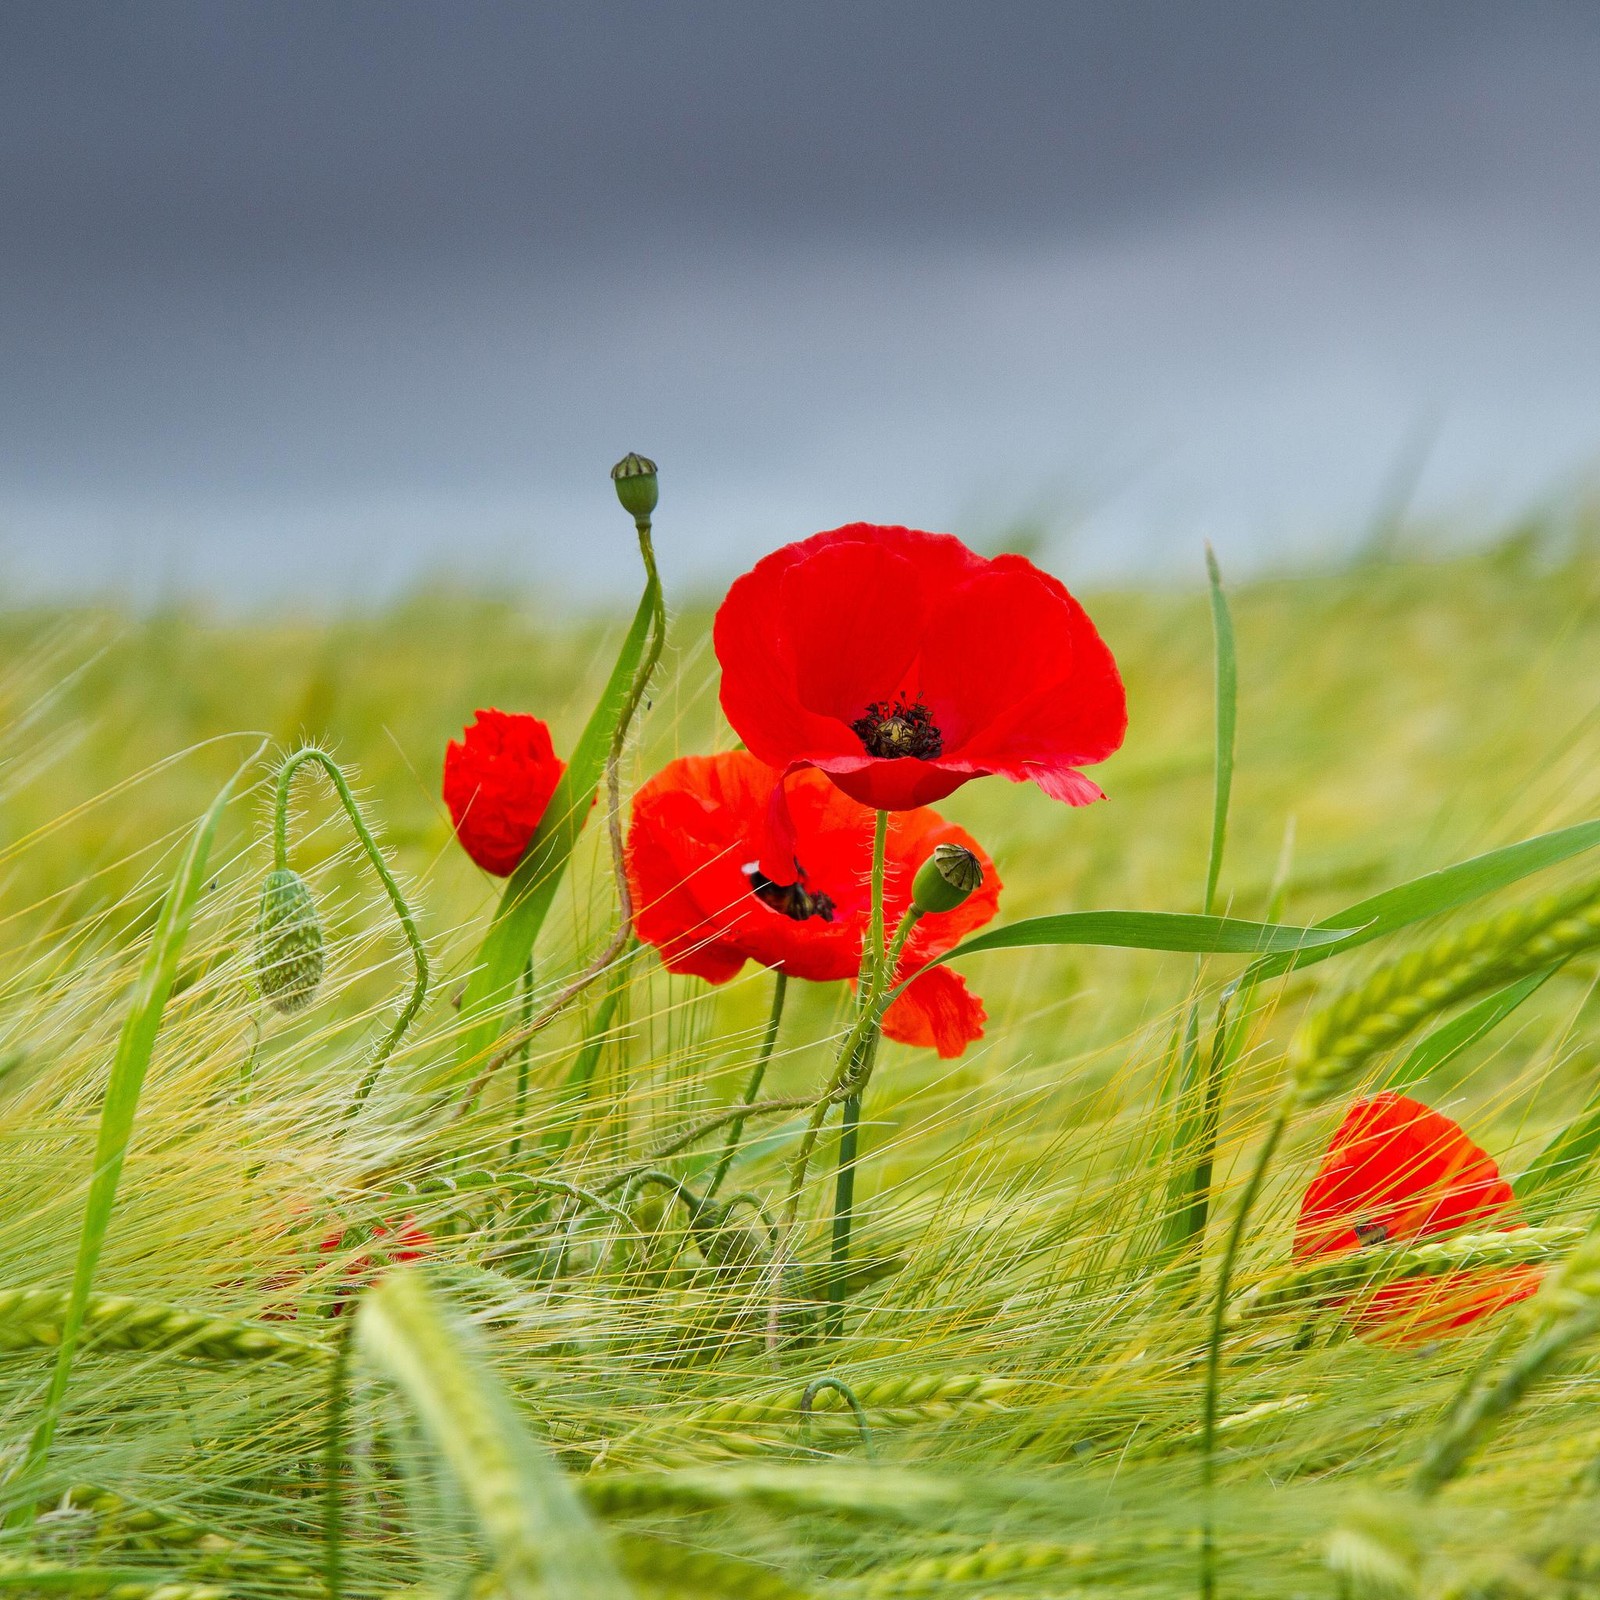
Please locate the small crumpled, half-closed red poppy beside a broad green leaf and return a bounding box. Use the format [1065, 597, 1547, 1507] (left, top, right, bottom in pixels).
[445, 710, 565, 878]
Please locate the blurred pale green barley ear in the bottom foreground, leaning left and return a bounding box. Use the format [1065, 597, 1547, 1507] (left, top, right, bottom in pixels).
[355, 1267, 629, 1600]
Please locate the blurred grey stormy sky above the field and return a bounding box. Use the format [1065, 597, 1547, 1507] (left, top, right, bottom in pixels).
[0, 0, 1600, 602]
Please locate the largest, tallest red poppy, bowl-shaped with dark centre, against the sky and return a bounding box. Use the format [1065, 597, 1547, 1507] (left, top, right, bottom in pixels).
[715, 522, 1128, 811]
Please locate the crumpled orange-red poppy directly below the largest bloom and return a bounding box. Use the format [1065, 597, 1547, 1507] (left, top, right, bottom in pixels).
[627, 750, 1000, 1056]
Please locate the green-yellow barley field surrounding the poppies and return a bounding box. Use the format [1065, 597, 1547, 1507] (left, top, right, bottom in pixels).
[0, 509, 1600, 1600]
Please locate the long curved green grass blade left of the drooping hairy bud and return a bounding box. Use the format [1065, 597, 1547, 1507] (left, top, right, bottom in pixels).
[21, 746, 266, 1478]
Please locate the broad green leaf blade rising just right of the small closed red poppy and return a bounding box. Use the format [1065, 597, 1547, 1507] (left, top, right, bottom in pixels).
[456, 579, 659, 1067]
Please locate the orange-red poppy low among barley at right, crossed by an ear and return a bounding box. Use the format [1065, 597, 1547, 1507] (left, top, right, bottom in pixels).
[1294, 1094, 1541, 1342]
